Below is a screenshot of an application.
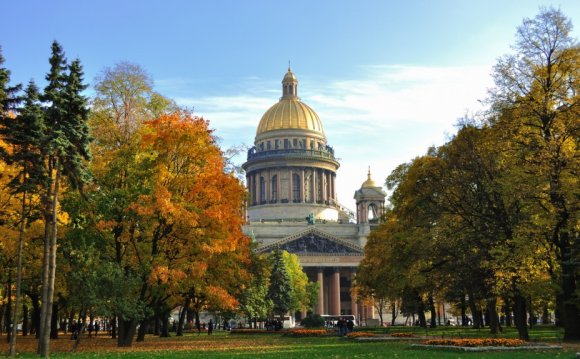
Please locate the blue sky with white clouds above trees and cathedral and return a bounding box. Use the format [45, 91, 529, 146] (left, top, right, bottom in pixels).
[0, 0, 580, 209]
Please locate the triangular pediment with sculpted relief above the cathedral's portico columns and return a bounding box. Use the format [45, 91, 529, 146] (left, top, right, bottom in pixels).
[260, 230, 363, 256]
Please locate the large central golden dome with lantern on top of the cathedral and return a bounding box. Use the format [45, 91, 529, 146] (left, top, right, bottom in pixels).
[256, 68, 324, 135]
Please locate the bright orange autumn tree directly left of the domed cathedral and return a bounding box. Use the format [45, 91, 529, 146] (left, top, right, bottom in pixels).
[135, 111, 249, 342]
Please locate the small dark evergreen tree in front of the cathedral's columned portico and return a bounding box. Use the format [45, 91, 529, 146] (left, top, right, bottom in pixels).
[268, 249, 292, 321]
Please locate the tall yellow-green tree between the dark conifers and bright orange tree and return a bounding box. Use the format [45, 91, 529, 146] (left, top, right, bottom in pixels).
[87, 62, 171, 346]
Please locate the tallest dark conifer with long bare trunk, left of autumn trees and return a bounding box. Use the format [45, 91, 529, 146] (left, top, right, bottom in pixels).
[39, 41, 90, 357]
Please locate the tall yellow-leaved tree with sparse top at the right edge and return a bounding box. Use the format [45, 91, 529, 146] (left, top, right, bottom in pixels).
[491, 8, 580, 340]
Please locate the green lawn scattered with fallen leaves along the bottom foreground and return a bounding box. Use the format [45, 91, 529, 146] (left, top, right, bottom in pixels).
[0, 327, 580, 359]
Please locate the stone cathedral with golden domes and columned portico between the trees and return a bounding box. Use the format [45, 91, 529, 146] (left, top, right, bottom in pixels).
[243, 68, 386, 323]
